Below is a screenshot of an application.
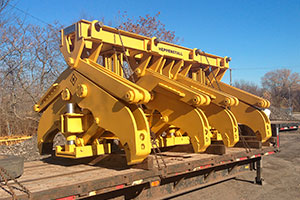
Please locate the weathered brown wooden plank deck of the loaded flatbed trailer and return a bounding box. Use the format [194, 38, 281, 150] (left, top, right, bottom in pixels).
[0, 147, 274, 200]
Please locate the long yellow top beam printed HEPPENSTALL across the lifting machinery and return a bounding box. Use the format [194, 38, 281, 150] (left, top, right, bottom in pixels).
[61, 20, 229, 68]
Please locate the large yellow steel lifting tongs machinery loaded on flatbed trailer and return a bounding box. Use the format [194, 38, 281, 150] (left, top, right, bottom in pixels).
[34, 20, 272, 165]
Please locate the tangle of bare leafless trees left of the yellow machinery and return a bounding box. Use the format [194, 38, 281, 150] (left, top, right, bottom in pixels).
[0, 12, 65, 135]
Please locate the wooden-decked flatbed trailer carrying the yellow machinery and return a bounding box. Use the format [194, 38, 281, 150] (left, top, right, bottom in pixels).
[0, 146, 278, 200]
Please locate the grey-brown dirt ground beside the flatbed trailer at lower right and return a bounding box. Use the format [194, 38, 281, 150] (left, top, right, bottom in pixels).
[172, 131, 300, 200]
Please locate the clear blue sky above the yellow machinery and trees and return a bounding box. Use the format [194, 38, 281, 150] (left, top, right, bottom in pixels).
[11, 0, 300, 84]
